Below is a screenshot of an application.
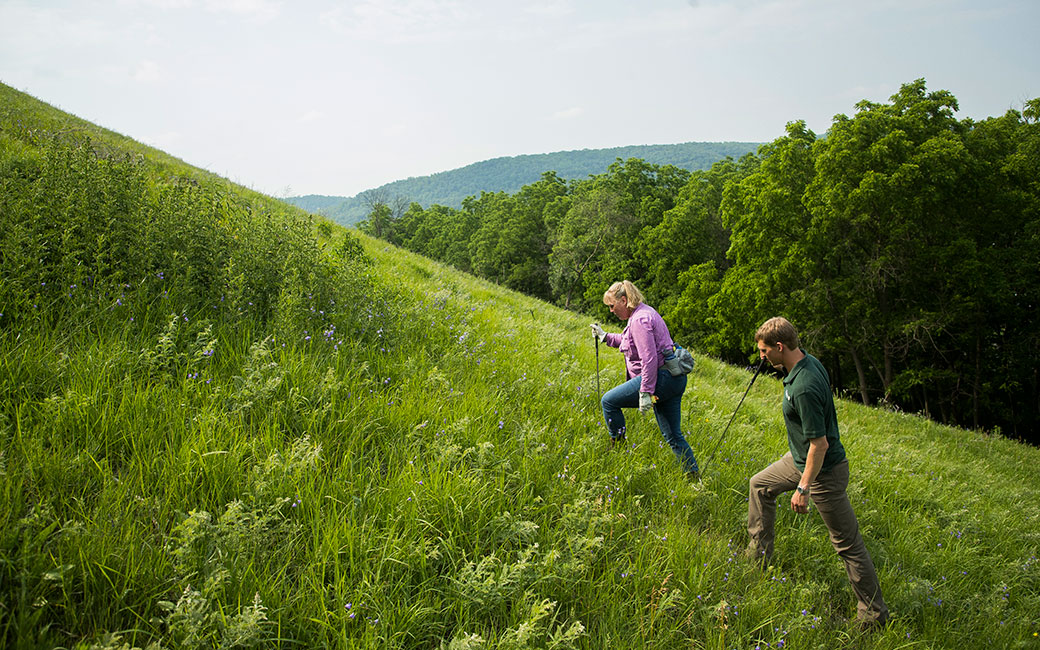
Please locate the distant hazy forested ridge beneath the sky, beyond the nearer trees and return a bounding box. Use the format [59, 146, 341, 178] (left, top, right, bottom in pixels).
[285, 142, 760, 225]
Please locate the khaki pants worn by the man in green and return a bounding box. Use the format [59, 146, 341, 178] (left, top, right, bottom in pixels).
[748, 452, 888, 623]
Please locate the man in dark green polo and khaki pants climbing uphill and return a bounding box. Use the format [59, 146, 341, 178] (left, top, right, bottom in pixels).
[748, 317, 888, 628]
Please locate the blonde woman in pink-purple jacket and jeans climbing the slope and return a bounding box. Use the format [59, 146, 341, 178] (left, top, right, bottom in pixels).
[592, 280, 698, 477]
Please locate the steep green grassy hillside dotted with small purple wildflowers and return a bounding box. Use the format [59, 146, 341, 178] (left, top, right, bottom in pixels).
[0, 83, 1040, 649]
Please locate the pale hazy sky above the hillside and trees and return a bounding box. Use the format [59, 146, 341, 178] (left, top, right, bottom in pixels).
[0, 0, 1040, 197]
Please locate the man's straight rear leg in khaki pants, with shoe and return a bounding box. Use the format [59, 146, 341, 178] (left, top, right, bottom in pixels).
[810, 461, 888, 625]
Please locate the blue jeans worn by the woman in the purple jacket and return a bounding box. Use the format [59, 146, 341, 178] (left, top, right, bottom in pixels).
[600, 368, 698, 472]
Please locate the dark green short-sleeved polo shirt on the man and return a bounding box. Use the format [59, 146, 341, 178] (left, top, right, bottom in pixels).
[783, 354, 846, 471]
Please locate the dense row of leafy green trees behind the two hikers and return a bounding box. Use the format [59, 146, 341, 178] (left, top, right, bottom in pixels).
[359, 79, 1040, 442]
